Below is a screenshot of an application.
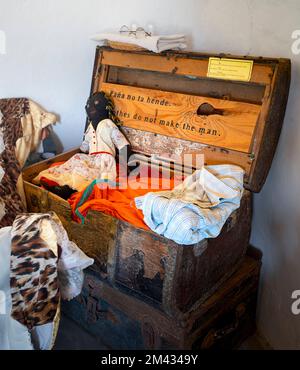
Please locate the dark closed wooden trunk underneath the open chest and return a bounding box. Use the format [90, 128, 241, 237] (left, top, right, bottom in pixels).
[63, 249, 260, 350]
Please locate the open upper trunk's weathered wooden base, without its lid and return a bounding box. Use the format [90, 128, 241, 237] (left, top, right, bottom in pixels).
[23, 156, 252, 315]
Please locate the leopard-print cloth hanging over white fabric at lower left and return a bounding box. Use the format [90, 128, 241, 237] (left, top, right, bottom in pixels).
[10, 214, 59, 329]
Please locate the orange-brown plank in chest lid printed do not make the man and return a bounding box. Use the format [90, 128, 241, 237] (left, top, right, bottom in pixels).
[101, 83, 260, 153]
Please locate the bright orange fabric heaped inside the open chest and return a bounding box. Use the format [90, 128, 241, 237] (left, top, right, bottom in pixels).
[68, 172, 178, 230]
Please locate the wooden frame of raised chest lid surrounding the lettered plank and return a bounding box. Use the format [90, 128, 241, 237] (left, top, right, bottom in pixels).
[92, 47, 290, 192]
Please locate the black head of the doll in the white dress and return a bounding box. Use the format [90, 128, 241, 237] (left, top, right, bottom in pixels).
[85, 91, 109, 127]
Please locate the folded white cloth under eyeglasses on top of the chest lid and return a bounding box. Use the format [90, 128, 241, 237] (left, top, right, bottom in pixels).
[91, 33, 186, 53]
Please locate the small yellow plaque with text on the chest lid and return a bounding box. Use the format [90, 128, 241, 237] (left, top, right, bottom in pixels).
[207, 58, 253, 81]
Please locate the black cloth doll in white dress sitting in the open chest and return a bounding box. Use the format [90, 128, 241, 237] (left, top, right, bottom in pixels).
[34, 92, 130, 198]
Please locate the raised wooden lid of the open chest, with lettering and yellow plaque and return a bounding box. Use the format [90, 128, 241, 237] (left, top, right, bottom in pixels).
[91, 47, 291, 192]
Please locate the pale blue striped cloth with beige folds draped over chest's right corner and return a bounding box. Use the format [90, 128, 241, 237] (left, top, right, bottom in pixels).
[135, 165, 244, 245]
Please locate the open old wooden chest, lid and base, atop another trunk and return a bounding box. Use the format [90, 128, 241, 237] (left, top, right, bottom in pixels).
[23, 47, 290, 317]
